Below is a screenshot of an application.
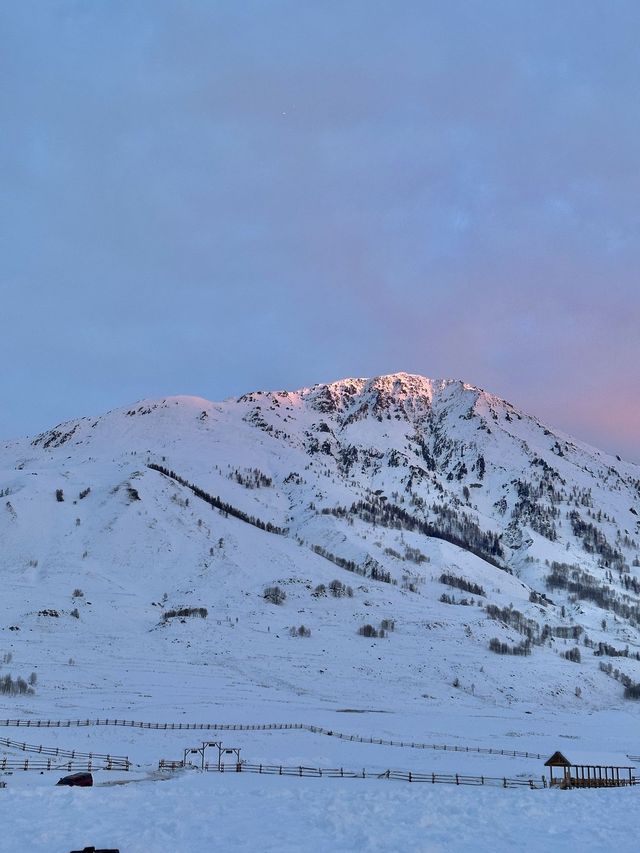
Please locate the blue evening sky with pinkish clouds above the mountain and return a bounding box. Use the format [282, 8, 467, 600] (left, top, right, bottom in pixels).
[0, 0, 640, 462]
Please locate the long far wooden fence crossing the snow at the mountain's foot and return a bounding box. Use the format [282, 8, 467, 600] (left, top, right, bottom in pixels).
[0, 719, 543, 759]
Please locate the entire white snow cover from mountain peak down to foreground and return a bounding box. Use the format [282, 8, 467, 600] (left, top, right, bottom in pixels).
[0, 374, 640, 853]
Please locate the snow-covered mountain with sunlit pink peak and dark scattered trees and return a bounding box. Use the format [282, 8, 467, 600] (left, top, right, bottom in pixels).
[0, 373, 640, 712]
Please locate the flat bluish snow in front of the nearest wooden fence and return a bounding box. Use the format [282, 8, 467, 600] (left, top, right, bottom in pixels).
[5, 772, 638, 853]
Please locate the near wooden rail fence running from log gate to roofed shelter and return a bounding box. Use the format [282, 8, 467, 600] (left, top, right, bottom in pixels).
[158, 759, 547, 789]
